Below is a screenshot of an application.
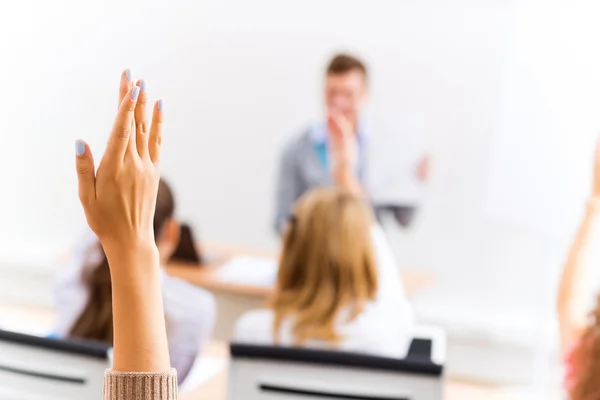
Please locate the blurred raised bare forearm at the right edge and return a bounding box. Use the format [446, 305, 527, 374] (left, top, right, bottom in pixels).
[557, 199, 600, 351]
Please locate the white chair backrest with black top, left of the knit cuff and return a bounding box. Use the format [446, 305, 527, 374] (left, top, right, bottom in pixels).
[0, 330, 111, 400]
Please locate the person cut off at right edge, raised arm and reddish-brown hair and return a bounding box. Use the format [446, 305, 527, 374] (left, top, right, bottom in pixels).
[557, 144, 600, 400]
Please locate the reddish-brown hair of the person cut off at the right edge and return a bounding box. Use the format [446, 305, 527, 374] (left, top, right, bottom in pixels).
[570, 296, 600, 400]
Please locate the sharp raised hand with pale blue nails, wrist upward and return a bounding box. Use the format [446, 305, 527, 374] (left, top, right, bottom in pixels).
[76, 70, 162, 255]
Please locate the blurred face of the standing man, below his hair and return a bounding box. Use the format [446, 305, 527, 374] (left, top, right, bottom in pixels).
[325, 70, 367, 123]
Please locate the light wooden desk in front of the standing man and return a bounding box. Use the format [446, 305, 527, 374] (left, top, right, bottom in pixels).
[166, 246, 433, 342]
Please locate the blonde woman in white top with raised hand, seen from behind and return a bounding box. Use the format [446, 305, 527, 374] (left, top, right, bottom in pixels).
[234, 111, 414, 357]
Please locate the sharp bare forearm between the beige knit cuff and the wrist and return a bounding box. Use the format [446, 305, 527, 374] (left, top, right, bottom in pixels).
[105, 244, 171, 372]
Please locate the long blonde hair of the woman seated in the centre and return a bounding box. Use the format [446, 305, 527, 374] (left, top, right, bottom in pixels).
[271, 189, 377, 345]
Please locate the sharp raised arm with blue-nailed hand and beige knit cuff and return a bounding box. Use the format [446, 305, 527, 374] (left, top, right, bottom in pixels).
[75, 71, 177, 400]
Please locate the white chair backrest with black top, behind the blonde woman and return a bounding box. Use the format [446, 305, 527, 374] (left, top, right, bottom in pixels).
[227, 326, 445, 400]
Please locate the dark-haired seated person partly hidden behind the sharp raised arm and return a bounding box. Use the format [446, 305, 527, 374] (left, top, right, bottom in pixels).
[55, 76, 216, 383]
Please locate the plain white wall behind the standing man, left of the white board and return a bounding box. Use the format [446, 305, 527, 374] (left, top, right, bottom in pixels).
[0, 0, 592, 360]
